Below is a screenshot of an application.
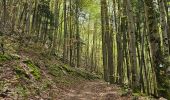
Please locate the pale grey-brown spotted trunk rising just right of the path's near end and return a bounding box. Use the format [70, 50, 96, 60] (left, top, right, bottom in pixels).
[126, 0, 138, 91]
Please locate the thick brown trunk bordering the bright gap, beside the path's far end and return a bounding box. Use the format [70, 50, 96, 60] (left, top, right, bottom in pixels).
[101, 0, 114, 84]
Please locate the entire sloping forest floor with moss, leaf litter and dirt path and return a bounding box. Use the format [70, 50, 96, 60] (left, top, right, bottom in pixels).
[0, 35, 155, 100]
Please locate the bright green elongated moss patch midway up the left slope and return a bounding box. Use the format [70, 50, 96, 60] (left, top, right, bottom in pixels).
[23, 60, 41, 80]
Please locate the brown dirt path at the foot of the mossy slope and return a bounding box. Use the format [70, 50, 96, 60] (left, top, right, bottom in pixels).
[59, 81, 131, 100]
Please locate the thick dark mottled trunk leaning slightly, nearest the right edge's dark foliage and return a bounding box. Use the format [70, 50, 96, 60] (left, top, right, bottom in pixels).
[145, 0, 162, 96]
